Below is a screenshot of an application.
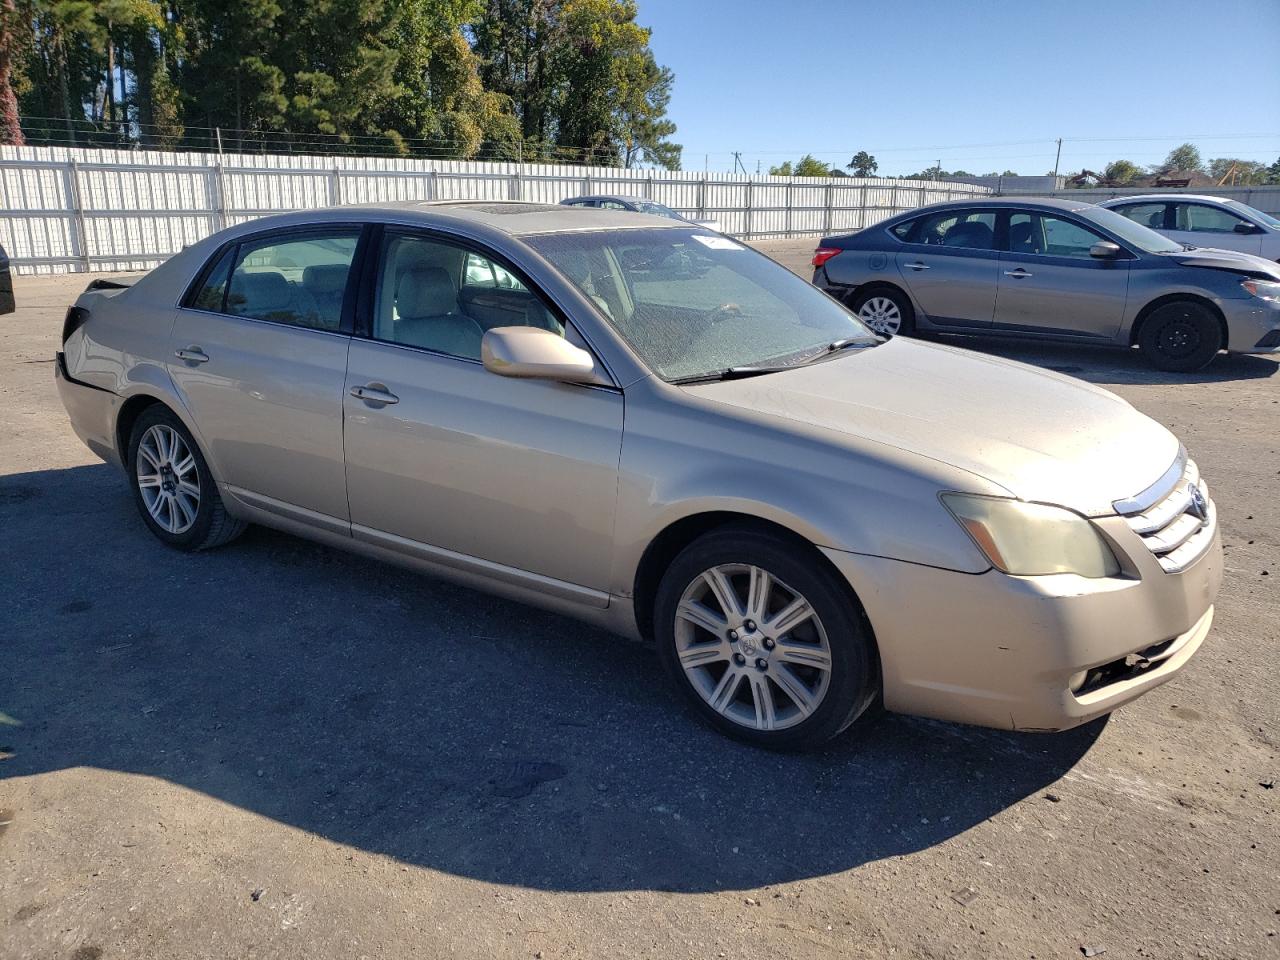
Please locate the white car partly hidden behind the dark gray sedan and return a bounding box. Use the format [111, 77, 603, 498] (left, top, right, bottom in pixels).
[1098, 193, 1280, 261]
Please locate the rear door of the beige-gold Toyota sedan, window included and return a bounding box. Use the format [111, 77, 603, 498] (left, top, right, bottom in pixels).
[168, 227, 360, 531]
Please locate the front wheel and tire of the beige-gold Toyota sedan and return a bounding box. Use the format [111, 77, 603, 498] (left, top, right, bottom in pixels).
[654, 529, 878, 750]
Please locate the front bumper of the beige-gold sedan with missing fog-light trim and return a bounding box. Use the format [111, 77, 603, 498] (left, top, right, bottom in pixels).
[824, 521, 1222, 731]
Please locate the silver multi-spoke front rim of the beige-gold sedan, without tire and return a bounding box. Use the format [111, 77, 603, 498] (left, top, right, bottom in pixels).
[676, 563, 831, 731]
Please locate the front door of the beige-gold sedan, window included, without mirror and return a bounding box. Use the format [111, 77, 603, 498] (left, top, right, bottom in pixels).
[344, 230, 623, 605]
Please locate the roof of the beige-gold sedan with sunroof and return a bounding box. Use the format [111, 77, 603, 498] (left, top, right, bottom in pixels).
[215, 200, 690, 237]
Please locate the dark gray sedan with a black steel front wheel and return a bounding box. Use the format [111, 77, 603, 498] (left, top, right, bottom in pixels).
[813, 198, 1280, 371]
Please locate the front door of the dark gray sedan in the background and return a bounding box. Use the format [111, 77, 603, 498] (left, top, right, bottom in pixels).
[995, 210, 1129, 339]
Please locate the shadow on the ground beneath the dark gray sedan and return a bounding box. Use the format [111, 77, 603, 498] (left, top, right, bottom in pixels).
[928, 334, 1280, 384]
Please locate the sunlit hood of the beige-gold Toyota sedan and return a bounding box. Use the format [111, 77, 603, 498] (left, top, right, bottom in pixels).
[684, 338, 1179, 516]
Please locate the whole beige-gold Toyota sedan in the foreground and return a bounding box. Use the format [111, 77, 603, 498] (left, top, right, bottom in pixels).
[56, 202, 1222, 748]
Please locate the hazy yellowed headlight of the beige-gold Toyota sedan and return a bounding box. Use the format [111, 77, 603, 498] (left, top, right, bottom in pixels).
[942, 493, 1120, 577]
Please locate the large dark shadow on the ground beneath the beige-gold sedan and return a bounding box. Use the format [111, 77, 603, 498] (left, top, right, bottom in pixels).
[0, 466, 1103, 891]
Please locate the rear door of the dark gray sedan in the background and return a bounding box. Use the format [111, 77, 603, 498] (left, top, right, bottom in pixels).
[897, 209, 1000, 326]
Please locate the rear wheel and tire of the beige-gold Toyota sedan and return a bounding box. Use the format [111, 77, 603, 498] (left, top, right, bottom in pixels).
[128, 403, 244, 552]
